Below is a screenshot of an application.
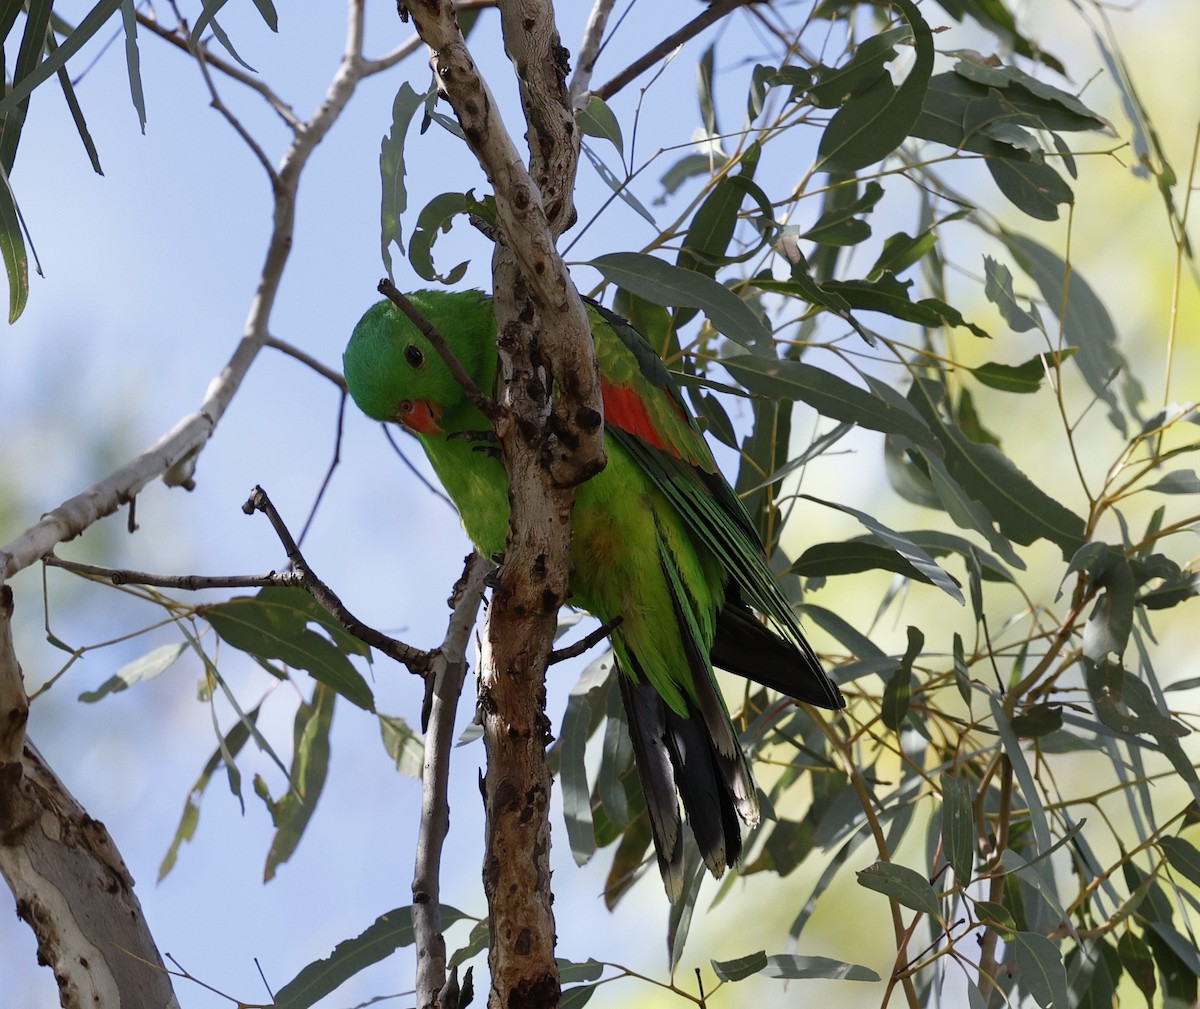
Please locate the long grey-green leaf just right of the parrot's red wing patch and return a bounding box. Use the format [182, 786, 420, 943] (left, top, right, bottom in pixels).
[721, 354, 936, 448]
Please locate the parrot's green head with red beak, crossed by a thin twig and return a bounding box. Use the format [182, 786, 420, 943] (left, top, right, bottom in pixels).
[342, 290, 496, 436]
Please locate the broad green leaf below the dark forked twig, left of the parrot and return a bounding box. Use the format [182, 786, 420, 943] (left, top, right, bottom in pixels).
[198, 588, 374, 711]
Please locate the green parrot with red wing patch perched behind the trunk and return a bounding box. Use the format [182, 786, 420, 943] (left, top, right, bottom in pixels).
[343, 290, 845, 901]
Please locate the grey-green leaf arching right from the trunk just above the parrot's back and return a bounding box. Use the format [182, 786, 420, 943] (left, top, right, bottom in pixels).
[589, 252, 772, 348]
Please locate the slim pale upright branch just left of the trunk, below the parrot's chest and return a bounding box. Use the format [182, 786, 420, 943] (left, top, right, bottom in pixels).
[413, 553, 491, 1009]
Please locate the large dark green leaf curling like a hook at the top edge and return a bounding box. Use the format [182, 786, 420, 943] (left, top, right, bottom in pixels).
[817, 0, 934, 172]
